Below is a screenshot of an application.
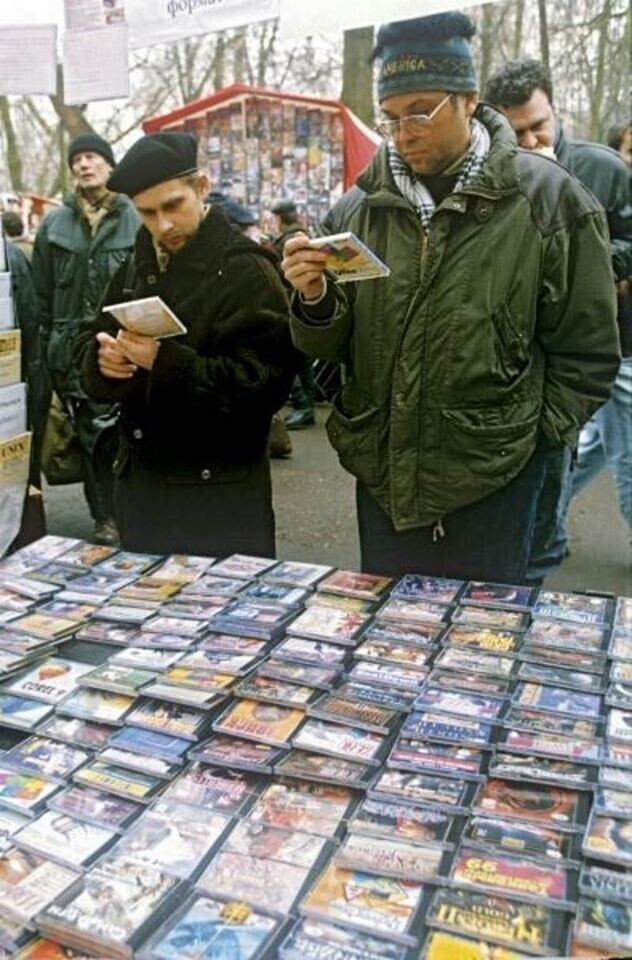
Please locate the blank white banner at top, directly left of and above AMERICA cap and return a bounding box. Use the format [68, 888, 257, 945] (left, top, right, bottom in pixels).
[279, 0, 506, 38]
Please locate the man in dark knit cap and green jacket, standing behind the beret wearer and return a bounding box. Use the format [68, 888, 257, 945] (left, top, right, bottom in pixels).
[33, 133, 139, 545]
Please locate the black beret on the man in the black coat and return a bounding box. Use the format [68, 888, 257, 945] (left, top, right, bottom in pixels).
[107, 133, 197, 197]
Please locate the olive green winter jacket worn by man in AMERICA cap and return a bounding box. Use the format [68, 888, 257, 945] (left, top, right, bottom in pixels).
[292, 105, 620, 530]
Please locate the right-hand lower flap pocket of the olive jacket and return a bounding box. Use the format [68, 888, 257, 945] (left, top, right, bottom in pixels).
[441, 405, 540, 476]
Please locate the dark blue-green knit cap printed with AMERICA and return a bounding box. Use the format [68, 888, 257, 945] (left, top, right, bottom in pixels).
[373, 12, 478, 101]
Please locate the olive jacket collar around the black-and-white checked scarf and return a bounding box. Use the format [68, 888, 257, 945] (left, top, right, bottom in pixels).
[357, 103, 518, 203]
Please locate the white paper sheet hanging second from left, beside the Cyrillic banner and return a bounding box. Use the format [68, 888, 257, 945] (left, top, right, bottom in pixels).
[64, 23, 129, 105]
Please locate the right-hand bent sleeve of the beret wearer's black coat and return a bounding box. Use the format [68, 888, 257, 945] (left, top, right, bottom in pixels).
[138, 253, 297, 413]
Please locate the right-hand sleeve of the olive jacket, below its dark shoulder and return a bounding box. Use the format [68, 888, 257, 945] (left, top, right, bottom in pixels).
[536, 212, 621, 447]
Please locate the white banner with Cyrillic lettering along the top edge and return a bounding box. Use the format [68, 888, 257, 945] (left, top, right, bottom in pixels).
[125, 0, 279, 47]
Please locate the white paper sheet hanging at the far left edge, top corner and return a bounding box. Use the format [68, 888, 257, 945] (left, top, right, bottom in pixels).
[0, 25, 57, 96]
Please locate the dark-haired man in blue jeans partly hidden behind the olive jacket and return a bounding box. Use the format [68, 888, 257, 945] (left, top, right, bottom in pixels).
[486, 60, 632, 572]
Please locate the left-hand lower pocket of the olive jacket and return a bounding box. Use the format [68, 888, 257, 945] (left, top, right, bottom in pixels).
[326, 397, 378, 486]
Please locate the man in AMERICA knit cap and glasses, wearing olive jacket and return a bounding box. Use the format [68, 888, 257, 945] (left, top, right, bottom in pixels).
[283, 12, 619, 583]
